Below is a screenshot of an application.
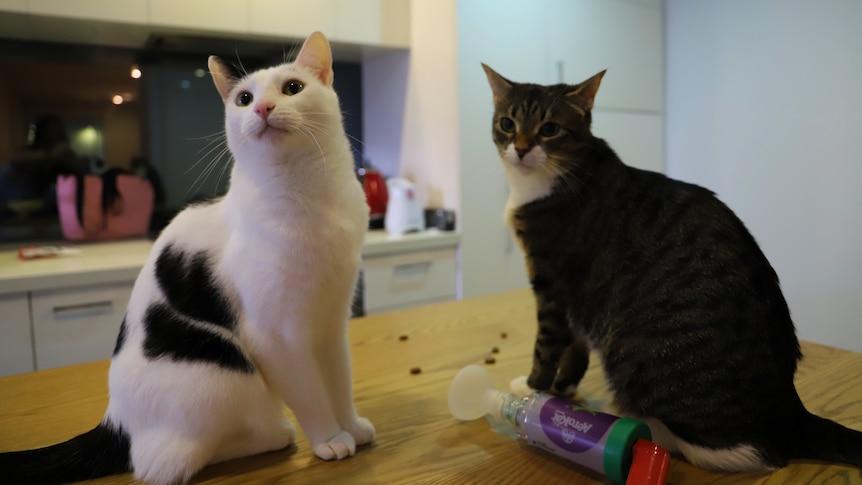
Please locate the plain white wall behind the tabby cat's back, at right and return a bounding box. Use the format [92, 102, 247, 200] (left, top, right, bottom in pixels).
[666, 0, 862, 352]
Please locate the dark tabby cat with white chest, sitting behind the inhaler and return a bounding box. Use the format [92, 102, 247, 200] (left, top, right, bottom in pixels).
[483, 65, 862, 471]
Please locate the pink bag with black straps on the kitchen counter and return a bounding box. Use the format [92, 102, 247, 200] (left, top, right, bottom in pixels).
[57, 171, 154, 241]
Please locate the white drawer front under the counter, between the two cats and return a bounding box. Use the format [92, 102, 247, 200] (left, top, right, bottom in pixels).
[362, 249, 456, 315]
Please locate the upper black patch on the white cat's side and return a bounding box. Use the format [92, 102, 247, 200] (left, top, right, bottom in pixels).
[156, 245, 236, 330]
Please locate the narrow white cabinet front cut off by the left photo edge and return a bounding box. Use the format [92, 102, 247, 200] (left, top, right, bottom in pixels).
[0, 293, 35, 376]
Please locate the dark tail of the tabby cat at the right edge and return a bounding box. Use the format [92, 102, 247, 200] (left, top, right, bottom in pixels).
[787, 411, 862, 468]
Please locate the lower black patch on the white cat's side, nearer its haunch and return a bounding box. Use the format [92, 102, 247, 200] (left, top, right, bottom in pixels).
[144, 303, 254, 373]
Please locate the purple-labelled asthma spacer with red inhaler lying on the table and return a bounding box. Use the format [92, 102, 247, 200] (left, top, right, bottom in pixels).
[449, 365, 668, 485]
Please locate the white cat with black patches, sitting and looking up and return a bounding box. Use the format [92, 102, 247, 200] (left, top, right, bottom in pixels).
[0, 32, 374, 484]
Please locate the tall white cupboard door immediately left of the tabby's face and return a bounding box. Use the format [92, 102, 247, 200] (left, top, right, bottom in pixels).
[457, 0, 548, 297]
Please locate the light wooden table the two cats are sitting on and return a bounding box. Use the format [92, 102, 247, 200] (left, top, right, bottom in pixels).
[0, 290, 862, 485]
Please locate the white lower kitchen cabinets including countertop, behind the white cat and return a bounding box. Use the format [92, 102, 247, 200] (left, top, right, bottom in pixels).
[0, 231, 460, 376]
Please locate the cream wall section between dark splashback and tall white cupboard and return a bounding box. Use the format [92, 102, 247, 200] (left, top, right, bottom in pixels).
[362, 0, 460, 209]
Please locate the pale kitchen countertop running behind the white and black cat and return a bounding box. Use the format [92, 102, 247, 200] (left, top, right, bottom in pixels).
[0, 230, 460, 295]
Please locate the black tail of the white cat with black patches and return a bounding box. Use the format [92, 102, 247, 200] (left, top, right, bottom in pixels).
[0, 421, 132, 485]
